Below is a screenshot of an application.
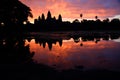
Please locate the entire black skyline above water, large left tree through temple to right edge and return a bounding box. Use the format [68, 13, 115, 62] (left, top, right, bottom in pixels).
[0, 0, 120, 33]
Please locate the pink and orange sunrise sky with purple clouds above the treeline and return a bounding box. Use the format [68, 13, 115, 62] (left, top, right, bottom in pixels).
[20, 0, 120, 22]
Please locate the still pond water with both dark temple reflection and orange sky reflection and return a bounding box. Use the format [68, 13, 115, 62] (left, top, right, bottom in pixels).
[25, 32, 120, 71]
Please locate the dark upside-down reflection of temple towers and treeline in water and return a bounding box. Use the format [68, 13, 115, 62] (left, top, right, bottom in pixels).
[24, 32, 119, 50]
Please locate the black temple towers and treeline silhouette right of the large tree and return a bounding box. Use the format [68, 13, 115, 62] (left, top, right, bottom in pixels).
[23, 11, 120, 31]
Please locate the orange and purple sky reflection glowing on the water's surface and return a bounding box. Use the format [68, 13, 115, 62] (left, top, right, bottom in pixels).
[26, 35, 120, 70]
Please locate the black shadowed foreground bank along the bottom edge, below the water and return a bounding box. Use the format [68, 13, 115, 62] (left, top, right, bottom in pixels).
[0, 64, 120, 80]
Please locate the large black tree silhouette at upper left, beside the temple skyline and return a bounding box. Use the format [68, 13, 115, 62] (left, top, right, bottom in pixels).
[0, 0, 33, 34]
